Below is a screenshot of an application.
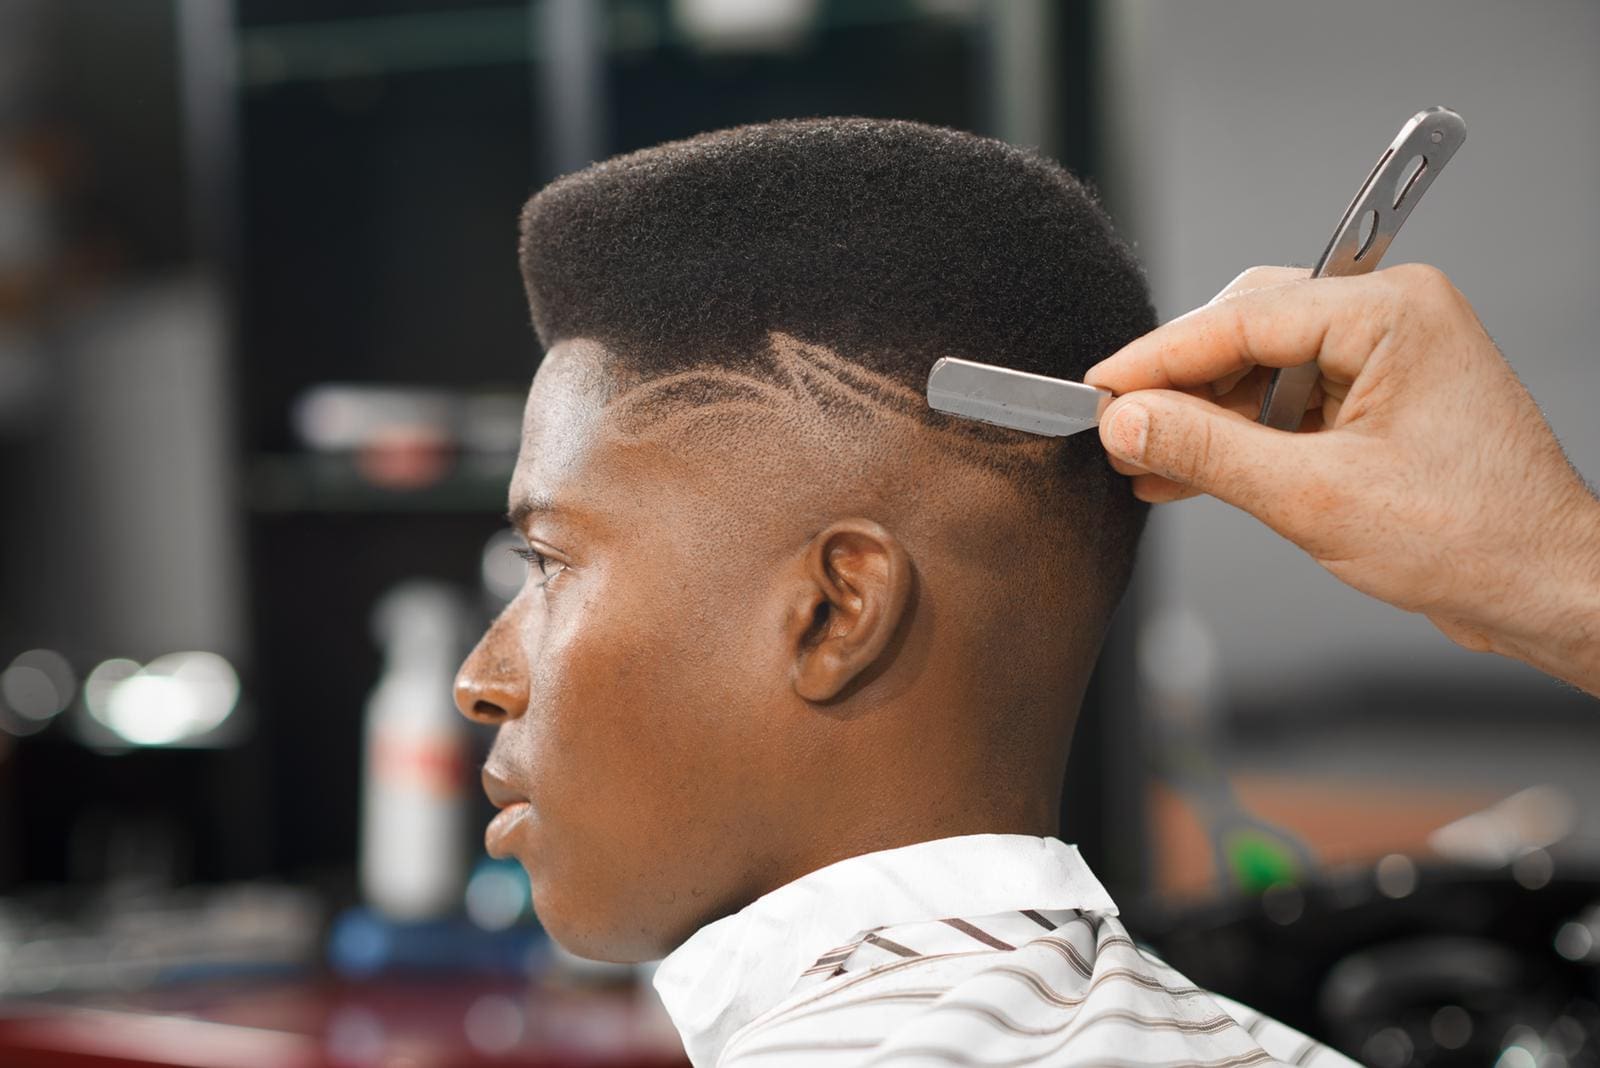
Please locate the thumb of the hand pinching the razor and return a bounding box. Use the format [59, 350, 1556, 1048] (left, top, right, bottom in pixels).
[1099, 390, 1315, 526]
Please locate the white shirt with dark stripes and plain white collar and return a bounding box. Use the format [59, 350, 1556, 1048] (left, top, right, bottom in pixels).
[656, 835, 1354, 1068]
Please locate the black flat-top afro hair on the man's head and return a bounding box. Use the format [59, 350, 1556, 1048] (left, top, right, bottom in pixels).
[520, 118, 1155, 600]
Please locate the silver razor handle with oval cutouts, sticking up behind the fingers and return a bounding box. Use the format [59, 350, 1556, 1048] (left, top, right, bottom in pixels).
[1261, 107, 1467, 430]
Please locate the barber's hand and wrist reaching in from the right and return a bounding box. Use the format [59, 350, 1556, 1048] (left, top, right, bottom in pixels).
[1085, 264, 1600, 694]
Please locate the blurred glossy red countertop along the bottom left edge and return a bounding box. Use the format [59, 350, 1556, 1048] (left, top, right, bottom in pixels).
[0, 980, 688, 1068]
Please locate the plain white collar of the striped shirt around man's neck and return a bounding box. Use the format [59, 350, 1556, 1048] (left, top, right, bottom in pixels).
[654, 835, 1117, 1065]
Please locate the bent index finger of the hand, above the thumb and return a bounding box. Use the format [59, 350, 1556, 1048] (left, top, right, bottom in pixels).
[1083, 272, 1392, 395]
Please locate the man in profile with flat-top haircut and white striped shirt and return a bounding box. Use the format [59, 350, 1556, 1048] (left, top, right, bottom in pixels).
[456, 118, 1347, 1066]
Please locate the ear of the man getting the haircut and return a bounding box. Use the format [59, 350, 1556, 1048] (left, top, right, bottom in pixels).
[787, 518, 912, 702]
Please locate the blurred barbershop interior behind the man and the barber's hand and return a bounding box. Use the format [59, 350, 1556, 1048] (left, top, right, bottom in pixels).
[0, 0, 1600, 1068]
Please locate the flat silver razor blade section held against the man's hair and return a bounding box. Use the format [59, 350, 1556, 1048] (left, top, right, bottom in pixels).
[928, 357, 1112, 438]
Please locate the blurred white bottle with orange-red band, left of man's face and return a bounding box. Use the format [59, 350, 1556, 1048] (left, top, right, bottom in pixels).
[360, 582, 475, 921]
